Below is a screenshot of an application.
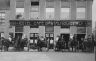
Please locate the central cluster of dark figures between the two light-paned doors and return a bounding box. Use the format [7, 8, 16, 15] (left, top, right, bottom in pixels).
[30, 36, 54, 51]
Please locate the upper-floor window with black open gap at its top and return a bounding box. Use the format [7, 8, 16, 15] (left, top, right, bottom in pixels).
[30, 1, 39, 19]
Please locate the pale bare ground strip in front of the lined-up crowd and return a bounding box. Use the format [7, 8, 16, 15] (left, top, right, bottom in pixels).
[0, 52, 95, 61]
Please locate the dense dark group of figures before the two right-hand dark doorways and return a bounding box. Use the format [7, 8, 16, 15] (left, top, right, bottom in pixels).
[55, 36, 94, 52]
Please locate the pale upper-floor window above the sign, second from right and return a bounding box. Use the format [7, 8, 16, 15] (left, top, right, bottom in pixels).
[61, 8, 70, 20]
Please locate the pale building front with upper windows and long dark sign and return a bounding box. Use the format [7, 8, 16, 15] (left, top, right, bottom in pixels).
[0, 0, 93, 41]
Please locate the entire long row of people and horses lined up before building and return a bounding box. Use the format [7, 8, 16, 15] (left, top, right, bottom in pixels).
[0, 36, 95, 51]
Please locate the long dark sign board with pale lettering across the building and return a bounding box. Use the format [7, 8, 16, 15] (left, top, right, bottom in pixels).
[10, 20, 92, 27]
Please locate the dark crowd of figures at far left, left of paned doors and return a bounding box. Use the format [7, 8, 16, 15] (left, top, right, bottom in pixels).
[0, 36, 28, 51]
